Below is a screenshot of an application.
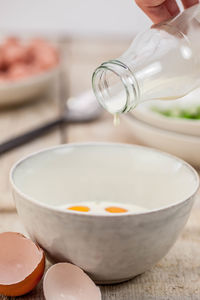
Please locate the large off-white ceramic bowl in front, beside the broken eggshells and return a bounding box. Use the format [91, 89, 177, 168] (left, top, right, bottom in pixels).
[10, 143, 199, 283]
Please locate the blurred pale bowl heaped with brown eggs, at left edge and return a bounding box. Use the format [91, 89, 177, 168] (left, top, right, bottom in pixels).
[0, 37, 59, 107]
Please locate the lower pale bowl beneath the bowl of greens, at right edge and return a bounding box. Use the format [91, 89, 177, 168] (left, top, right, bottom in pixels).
[124, 115, 200, 168]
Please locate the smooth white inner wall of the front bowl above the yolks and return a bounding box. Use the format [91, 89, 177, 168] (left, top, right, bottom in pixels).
[12, 143, 198, 209]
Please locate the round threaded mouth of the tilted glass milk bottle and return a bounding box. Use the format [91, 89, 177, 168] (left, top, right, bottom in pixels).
[92, 60, 140, 114]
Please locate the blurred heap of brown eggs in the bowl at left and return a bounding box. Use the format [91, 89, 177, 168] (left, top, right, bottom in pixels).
[0, 37, 59, 83]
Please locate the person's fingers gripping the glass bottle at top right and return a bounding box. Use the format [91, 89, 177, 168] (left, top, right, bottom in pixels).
[135, 0, 199, 24]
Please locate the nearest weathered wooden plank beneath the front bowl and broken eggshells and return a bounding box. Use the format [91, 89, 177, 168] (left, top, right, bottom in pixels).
[0, 199, 200, 300]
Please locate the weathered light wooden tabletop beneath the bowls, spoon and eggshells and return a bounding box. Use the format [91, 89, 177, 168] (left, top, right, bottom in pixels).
[0, 39, 200, 300]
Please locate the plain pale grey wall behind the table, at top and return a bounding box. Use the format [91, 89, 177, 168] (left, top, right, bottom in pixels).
[0, 0, 151, 38]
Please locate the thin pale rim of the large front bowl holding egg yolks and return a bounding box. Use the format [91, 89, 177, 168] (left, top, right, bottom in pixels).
[9, 142, 200, 218]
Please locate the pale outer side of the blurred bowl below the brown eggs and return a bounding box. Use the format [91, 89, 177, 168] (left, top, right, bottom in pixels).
[0, 67, 58, 107]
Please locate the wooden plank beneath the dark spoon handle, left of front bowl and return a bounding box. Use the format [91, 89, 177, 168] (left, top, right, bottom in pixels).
[0, 92, 60, 208]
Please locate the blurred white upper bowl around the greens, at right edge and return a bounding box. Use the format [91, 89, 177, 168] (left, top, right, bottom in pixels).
[132, 89, 200, 136]
